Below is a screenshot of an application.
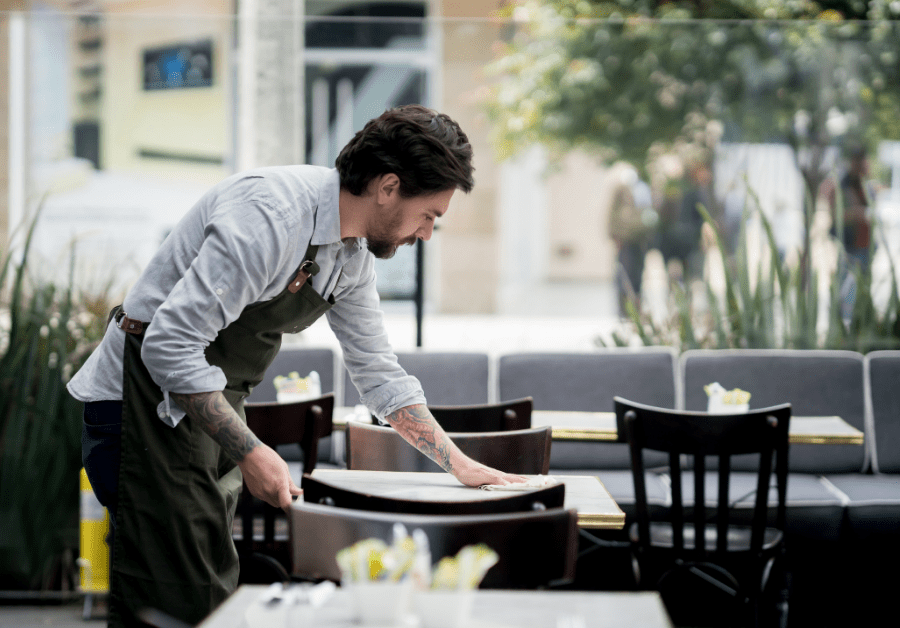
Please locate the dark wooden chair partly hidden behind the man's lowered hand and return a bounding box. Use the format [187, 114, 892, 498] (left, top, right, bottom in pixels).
[235, 393, 334, 584]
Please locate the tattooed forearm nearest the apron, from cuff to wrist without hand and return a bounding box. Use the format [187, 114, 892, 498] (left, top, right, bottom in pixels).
[169, 392, 261, 462]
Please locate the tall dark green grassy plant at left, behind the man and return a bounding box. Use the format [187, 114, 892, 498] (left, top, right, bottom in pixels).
[0, 215, 107, 589]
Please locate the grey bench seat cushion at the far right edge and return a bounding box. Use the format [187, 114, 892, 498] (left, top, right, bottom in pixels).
[825, 473, 900, 539]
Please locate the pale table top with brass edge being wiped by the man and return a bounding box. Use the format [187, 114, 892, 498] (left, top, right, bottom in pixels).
[313, 469, 625, 530]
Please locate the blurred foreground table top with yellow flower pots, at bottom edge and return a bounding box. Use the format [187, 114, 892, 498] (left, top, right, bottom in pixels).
[197, 585, 673, 628]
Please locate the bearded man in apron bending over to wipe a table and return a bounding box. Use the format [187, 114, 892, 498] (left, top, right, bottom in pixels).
[69, 105, 523, 626]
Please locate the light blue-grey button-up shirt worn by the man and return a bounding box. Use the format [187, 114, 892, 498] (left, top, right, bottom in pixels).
[68, 166, 425, 427]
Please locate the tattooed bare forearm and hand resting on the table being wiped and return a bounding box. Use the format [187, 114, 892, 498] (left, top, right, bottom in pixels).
[385, 405, 526, 486]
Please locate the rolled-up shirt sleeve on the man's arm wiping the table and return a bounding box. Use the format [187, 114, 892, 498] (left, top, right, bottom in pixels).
[327, 255, 425, 419]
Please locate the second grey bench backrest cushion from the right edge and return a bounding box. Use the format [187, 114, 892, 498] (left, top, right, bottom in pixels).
[681, 349, 867, 473]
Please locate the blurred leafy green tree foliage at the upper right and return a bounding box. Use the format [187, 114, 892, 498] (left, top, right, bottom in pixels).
[487, 0, 900, 192]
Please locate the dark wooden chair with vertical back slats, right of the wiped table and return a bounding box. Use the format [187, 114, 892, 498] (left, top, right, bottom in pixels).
[615, 397, 791, 625]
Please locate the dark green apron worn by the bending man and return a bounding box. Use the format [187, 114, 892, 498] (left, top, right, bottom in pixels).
[109, 245, 334, 627]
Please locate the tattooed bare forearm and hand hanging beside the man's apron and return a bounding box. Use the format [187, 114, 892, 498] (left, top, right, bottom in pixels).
[169, 392, 303, 510]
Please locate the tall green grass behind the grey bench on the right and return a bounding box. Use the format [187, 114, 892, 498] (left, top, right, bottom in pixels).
[598, 185, 900, 353]
